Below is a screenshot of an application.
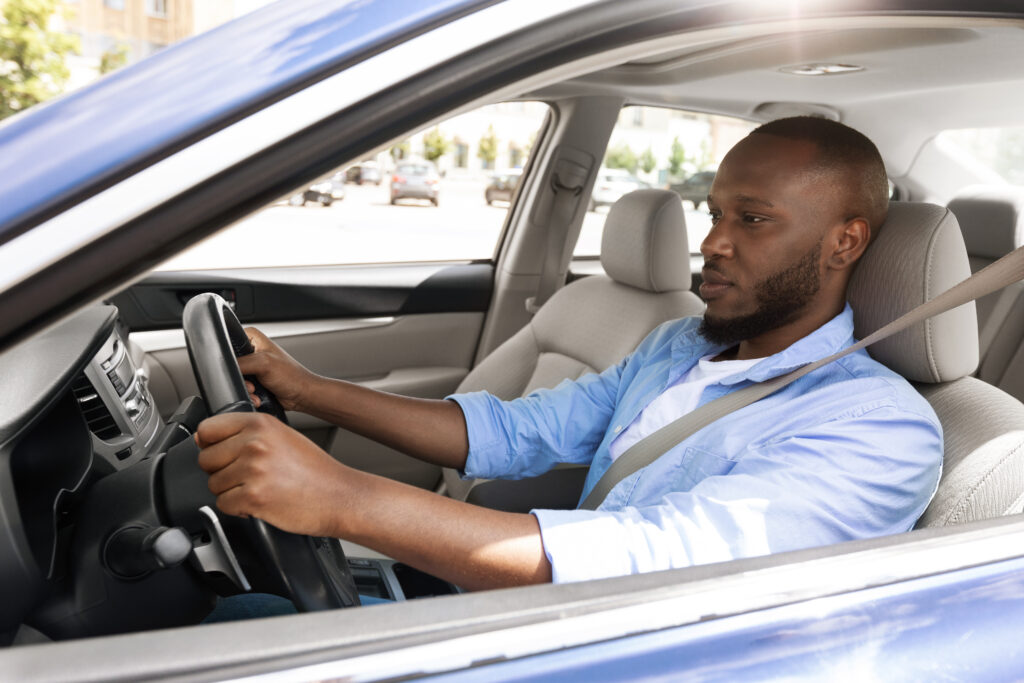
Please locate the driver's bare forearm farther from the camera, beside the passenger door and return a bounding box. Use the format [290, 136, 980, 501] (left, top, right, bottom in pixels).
[297, 378, 469, 469]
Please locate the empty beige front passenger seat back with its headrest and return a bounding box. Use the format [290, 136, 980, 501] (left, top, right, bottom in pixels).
[444, 189, 703, 502]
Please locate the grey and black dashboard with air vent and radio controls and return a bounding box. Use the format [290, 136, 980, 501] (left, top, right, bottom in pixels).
[0, 305, 205, 643]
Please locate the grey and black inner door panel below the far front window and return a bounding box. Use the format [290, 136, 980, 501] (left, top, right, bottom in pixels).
[114, 263, 493, 488]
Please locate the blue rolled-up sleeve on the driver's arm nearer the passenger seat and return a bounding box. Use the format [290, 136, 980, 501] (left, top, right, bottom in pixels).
[449, 358, 629, 479]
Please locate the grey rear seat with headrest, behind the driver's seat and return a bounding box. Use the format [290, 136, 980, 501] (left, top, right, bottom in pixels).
[948, 186, 1024, 400]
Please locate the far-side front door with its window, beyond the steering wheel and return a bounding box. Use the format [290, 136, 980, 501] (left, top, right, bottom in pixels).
[113, 102, 548, 488]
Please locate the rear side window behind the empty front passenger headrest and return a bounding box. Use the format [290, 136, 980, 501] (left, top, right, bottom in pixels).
[573, 106, 757, 257]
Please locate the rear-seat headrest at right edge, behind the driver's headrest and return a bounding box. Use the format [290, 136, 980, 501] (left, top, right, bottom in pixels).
[949, 185, 1024, 261]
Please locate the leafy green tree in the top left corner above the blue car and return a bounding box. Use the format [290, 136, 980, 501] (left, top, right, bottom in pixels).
[0, 0, 79, 119]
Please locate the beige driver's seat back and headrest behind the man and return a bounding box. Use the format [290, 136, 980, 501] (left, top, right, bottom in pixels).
[849, 202, 1024, 526]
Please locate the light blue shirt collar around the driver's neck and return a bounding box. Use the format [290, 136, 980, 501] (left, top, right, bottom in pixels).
[672, 303, 854, 385]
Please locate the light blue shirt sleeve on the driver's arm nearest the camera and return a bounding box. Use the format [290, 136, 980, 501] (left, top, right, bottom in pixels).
[532, 405, 942, 583]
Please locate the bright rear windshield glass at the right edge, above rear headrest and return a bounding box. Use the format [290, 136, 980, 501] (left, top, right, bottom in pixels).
[936, 126, 1024, 185]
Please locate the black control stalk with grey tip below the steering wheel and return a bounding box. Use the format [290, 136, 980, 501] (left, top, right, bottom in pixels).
[103, 525, 193, 579]
